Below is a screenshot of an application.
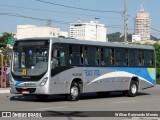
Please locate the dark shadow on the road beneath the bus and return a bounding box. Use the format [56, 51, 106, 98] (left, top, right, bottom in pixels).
[10, 92, 150, 102]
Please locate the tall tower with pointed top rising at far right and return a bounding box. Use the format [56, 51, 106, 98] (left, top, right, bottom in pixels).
[134, 7, 151, 42]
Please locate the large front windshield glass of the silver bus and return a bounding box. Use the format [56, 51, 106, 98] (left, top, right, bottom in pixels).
[12, 40, 49, 76]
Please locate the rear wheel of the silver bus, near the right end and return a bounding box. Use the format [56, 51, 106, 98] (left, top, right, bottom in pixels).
[127, 81, 138, 97]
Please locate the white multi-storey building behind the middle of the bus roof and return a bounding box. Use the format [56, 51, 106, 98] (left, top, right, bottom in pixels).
[70, 20, 107, 42]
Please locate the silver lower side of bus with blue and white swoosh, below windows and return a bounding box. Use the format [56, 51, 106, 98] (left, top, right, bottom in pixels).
[50, 67, 155, 94]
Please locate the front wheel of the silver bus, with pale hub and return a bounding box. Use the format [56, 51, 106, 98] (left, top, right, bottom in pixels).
[67, 82, 80, 101]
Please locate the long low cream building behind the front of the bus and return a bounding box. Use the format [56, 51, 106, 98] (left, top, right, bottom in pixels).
[16, 25, 68, 39]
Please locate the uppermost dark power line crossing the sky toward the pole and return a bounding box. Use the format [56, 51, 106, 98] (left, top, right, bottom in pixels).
[36, 0, 123, 14]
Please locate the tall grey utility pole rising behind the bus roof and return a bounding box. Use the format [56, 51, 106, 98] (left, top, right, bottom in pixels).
[124, 0, 128, 43]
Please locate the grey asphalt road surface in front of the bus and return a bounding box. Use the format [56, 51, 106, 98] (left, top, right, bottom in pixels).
[0, 85, 160, 120]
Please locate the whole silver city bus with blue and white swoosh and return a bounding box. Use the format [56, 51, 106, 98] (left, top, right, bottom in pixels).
[11, 38, 156, 101]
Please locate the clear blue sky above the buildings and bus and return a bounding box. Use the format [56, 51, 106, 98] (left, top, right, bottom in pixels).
[0, 0, 160, 38]
